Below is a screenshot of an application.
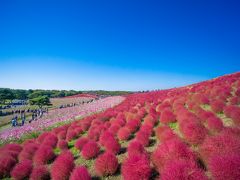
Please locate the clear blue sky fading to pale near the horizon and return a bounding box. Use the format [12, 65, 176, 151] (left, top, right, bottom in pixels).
[0, 0, 240, 90]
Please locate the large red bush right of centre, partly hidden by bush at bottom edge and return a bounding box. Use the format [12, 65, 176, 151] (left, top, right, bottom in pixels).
[151, 139, 196, 172]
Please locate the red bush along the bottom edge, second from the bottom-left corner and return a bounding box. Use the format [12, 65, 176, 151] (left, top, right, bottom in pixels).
[11, 159, 32, 180]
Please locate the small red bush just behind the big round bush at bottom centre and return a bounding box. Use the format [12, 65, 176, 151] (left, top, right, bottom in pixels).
[127, 140, 147, 156]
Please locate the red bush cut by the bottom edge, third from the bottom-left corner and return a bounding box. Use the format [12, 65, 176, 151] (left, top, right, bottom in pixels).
[30, 165, 50, 180]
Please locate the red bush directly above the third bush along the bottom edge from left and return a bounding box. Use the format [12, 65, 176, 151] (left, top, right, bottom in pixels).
[33, 145, 55, 165]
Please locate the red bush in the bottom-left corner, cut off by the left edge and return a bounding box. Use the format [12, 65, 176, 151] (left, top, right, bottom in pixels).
[0, 155, 17, 178]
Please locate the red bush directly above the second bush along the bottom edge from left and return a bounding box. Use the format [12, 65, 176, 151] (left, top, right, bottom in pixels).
[18, 143, 39, 161]
